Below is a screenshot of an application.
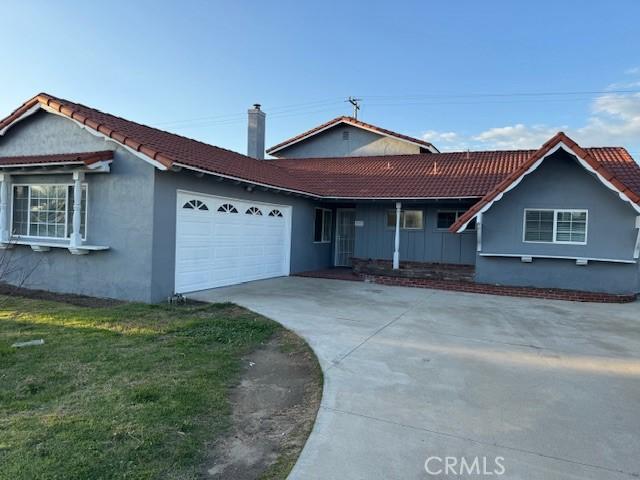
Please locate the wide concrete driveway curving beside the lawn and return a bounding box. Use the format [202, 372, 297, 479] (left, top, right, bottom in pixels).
[196, 277, 640, 480]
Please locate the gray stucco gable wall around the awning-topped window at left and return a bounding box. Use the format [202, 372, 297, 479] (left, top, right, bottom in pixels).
[0, 113, 158, 302]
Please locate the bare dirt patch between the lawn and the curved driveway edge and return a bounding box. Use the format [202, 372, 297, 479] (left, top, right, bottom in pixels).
[203, 331, 322, 480]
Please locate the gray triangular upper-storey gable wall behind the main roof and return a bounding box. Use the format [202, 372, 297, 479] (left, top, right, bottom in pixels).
[276, 125, 420, 158]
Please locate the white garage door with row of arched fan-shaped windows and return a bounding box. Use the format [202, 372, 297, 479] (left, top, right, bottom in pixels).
[175, 191, 291, 293]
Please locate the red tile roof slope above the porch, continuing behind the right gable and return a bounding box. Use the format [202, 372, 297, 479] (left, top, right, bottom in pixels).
[266, 147, 640, 198]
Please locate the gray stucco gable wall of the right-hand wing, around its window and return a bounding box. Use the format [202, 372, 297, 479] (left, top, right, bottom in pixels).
[476, 151, 640, 293]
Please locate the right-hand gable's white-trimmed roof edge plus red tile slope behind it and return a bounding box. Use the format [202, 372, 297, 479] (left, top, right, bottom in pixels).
[449, 132, 640, 232]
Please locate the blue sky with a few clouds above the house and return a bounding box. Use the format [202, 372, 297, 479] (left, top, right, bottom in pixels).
[0, 0, 640, 159]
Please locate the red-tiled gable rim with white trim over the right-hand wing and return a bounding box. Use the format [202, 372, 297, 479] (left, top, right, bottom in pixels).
[449, 132, 640, 233]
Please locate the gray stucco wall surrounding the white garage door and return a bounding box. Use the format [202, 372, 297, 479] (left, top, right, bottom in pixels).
[152, 171, 335, 301]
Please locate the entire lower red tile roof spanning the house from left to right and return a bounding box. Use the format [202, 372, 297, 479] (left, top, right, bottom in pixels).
[0, 93, 640, 203]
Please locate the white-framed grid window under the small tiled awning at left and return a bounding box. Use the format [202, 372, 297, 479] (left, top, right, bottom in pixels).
[11, 184, 87, 239]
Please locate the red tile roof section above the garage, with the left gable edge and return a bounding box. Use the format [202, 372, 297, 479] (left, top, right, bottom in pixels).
[0, 93, 320, 194]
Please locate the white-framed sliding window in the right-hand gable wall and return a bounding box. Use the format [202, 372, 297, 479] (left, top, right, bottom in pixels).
[523, 209, 588, 245]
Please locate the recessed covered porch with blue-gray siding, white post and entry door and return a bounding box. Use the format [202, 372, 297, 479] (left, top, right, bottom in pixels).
[333, 198, 480, 272]
